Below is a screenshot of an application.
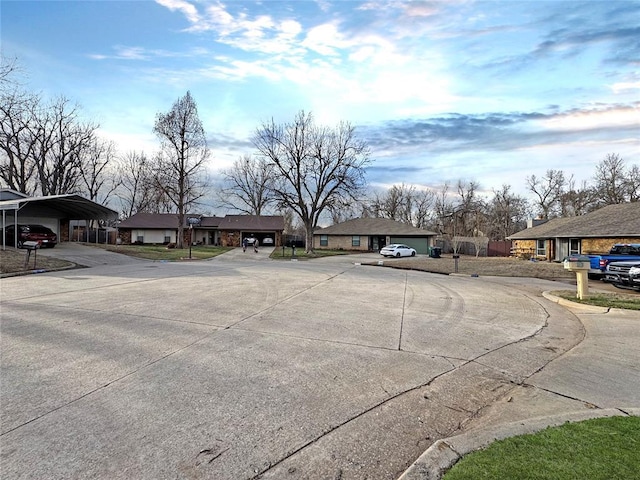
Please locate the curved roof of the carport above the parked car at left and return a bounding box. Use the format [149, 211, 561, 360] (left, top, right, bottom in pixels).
[0, 194, 118, 220]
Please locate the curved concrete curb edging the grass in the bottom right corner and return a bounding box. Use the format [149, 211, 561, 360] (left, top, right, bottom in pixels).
[398, 408, 640, 480]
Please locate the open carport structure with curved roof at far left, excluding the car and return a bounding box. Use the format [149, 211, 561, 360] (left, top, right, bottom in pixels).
[0, 188, 118, 248]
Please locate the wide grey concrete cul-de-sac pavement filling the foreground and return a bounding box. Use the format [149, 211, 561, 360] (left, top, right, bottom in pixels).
[0, 253, 584, 480]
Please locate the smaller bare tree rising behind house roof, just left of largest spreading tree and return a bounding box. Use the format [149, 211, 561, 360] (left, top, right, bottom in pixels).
[219, 155, 274, 215]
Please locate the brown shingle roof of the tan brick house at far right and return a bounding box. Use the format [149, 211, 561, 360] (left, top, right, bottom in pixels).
[507, 202, 640, 240]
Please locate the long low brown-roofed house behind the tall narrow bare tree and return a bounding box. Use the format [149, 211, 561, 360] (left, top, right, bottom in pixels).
[118, 212, 284, 247]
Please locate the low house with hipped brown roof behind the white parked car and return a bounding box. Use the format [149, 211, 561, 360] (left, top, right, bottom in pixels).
[313, 218, 437, 254]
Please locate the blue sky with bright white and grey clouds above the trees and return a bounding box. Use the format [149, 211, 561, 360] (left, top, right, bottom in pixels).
[0, 0, 640, 208]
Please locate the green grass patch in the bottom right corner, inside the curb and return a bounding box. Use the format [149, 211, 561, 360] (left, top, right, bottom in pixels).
[442, 417, 640, 480]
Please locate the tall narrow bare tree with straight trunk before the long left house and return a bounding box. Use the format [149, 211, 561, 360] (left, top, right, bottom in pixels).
[153, 92, 209, 248]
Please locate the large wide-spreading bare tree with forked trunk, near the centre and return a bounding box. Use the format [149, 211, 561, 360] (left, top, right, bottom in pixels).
[253, 111, 369, 251]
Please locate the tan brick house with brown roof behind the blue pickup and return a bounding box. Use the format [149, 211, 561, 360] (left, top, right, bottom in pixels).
[507, 202, 640, 261]
